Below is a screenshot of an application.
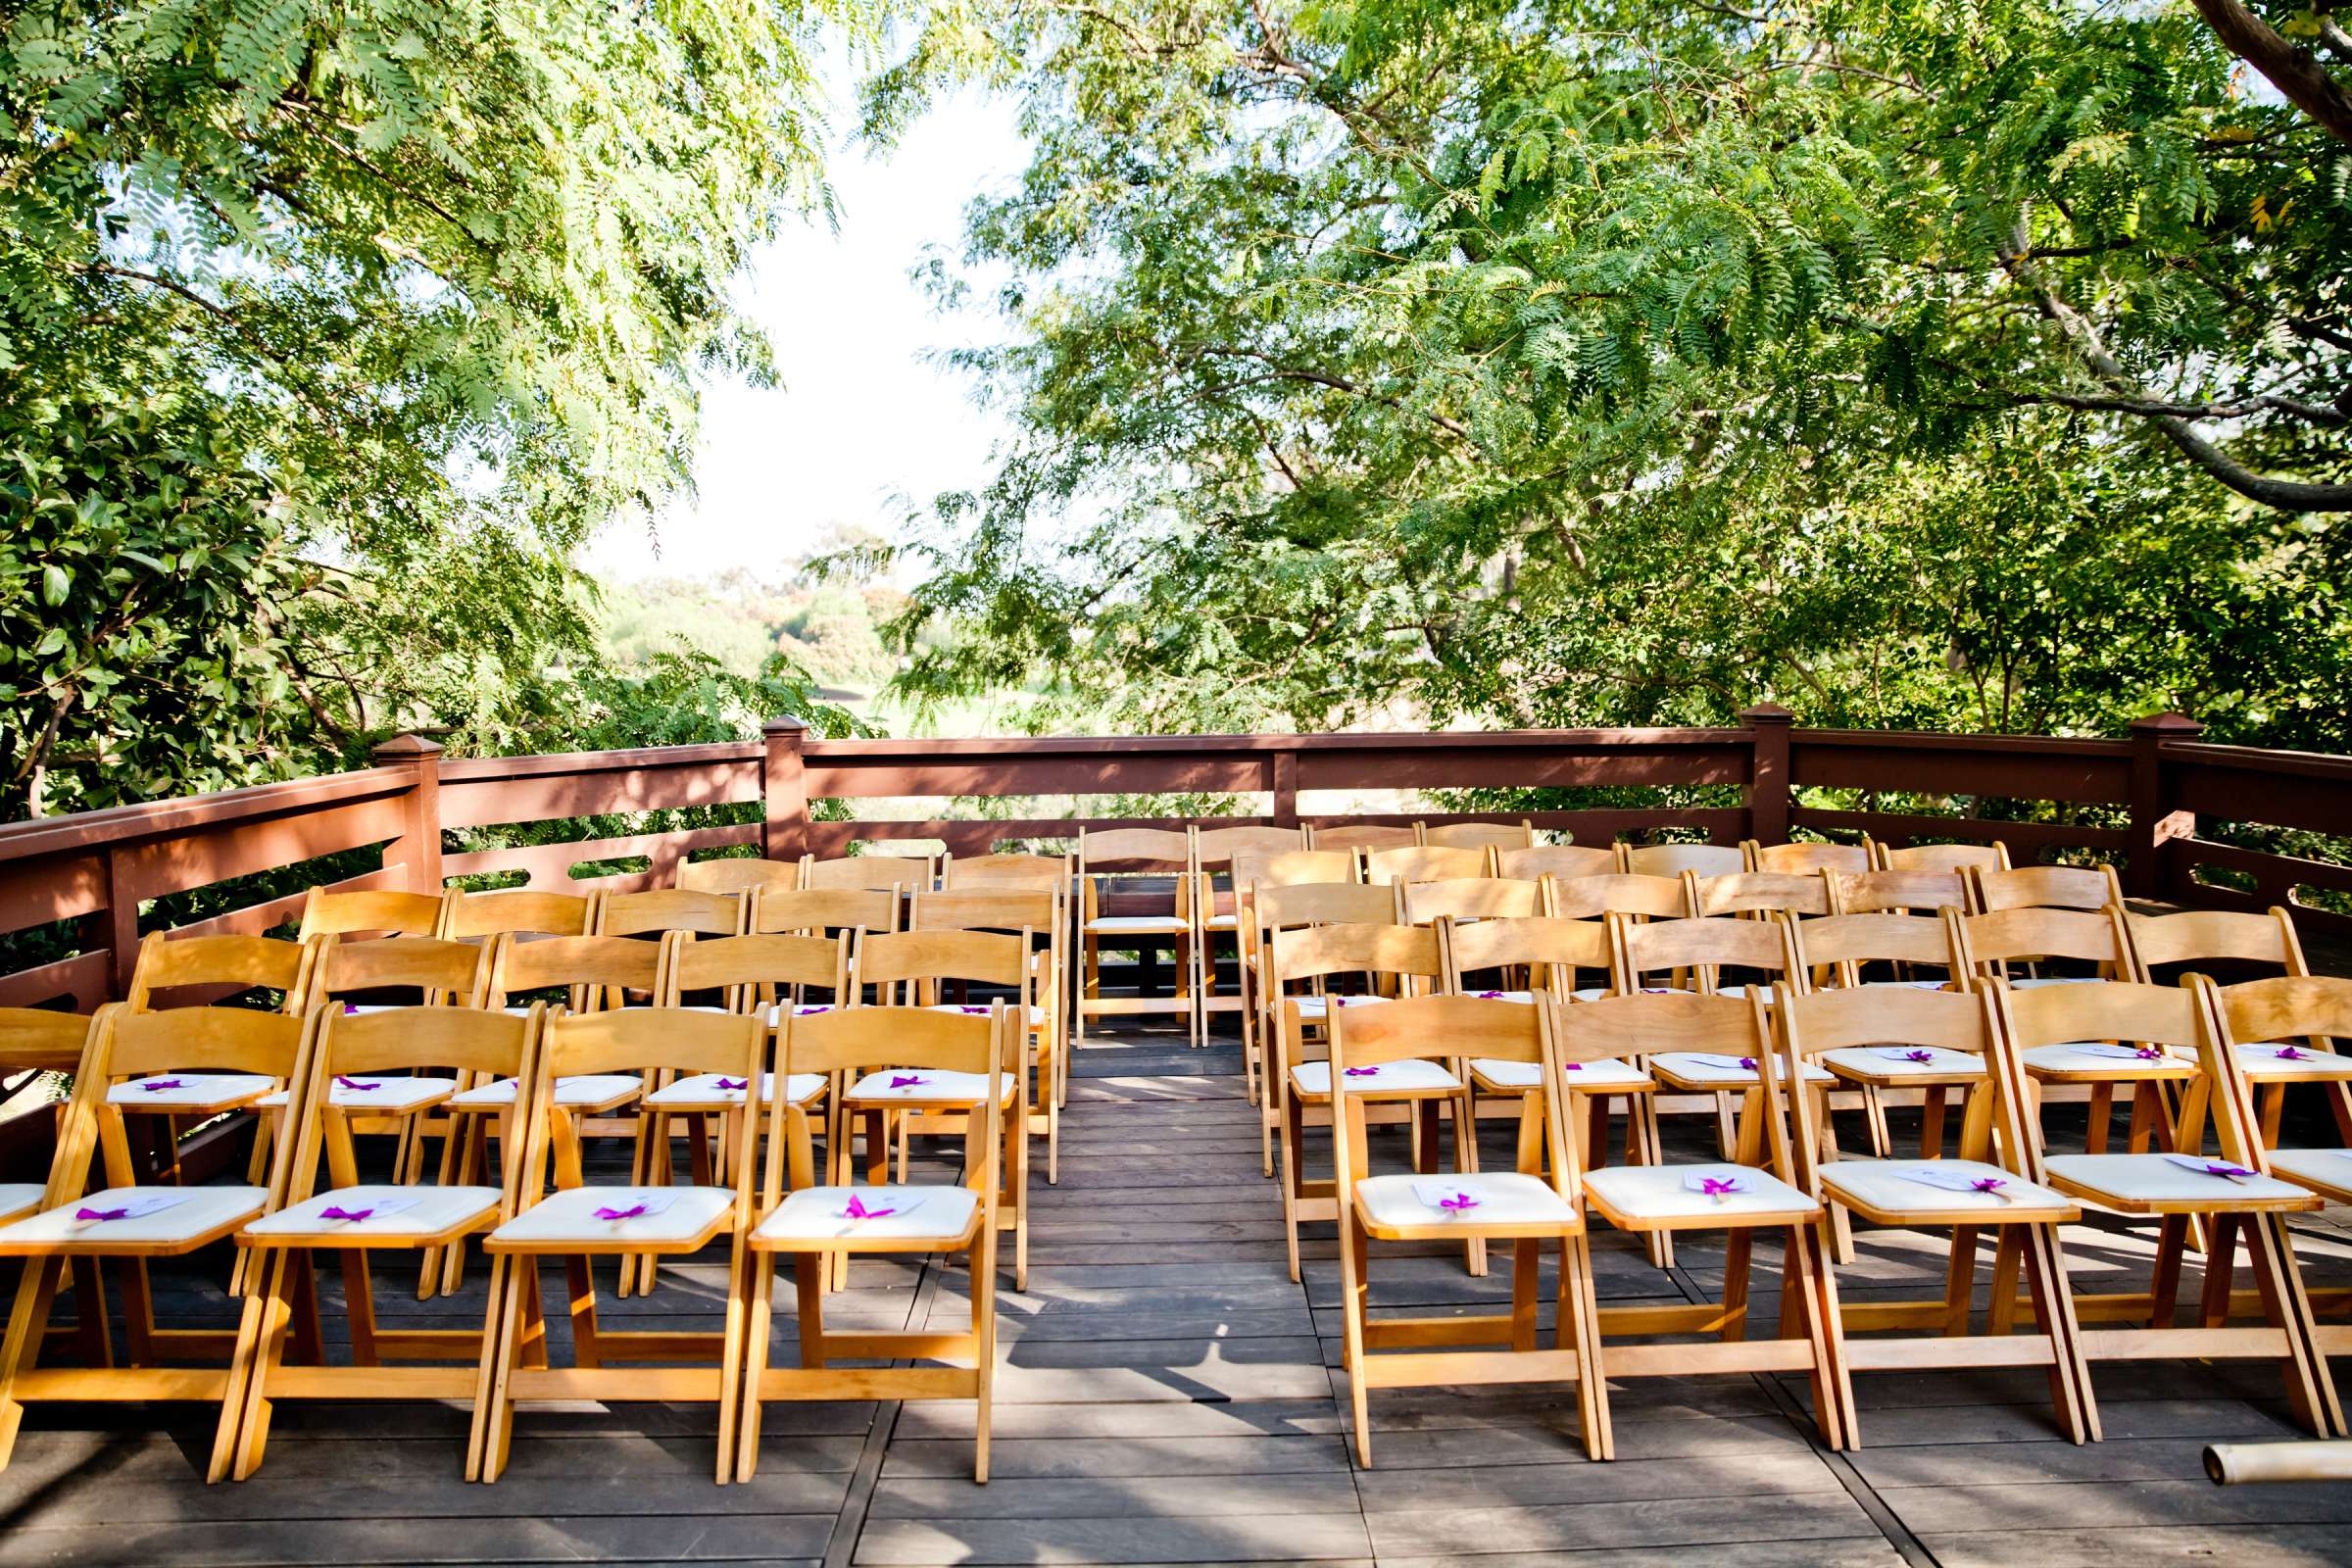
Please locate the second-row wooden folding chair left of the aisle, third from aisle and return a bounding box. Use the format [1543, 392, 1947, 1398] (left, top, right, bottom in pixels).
[461, 936, 670, 1296]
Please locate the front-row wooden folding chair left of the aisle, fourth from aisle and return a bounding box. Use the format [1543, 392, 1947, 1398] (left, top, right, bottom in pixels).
[0, 1004, 318, 1467]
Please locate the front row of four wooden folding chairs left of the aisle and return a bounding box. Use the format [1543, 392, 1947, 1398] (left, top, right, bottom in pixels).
[0, 1001, 1023, 1481]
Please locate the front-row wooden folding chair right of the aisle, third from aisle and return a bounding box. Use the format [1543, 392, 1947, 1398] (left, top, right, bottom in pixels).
[1774, 982, 2098, 1448]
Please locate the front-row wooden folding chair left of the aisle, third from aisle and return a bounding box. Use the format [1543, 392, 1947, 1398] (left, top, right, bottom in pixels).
[207, 1006, 546, 1481]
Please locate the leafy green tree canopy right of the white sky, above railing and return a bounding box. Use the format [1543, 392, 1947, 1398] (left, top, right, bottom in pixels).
[868, 0, 2352, 748]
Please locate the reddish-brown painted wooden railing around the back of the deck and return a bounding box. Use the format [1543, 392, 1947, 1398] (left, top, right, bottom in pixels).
[0, 706, 2352, 1008]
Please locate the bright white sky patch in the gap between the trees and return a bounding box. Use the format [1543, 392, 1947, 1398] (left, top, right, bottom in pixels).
[586, 92, 1028, 581]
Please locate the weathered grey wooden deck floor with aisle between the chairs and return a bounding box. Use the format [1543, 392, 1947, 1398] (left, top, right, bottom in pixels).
[0, 1037, 2352, 1568]
